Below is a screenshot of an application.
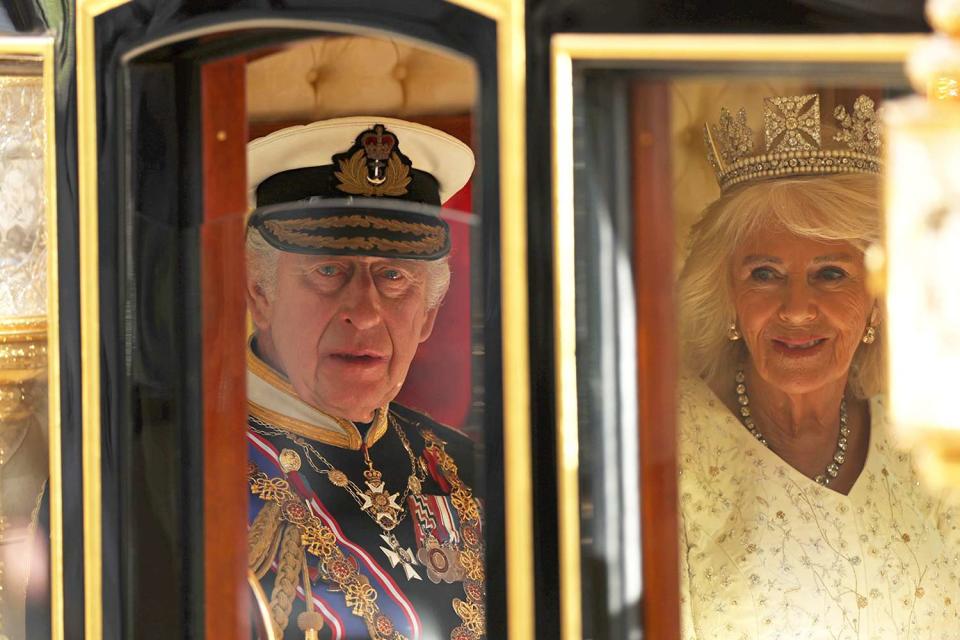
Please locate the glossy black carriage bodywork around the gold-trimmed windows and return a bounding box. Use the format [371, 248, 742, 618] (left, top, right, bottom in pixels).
[4, 0, 926, 638]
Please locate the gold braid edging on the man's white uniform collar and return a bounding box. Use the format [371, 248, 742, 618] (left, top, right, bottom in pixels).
[247, 338, 389, 450]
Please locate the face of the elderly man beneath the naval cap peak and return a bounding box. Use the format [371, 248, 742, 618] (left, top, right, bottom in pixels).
[248, 252, 437, 421]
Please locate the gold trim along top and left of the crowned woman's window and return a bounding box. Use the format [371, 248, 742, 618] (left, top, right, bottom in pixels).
[556, 33, 923, 640]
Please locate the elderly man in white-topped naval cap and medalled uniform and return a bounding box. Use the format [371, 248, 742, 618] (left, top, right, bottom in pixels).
[247, 117, 485, 640]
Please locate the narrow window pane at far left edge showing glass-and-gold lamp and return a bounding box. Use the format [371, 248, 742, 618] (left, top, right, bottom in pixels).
[0, 71, 48, 639]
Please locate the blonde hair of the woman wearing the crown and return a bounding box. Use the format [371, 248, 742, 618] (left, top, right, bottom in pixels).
[679, 174, 884, 398]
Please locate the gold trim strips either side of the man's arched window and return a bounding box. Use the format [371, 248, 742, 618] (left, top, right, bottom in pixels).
[77, 5, 532, 640]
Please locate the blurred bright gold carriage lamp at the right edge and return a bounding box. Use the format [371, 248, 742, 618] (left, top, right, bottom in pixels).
[880, 0, 960, 486]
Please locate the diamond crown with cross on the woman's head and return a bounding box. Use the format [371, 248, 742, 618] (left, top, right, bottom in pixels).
[703, 94, 882, 191]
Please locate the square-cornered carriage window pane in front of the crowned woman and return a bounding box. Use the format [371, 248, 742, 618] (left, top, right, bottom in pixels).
[571, 46, 920, 638]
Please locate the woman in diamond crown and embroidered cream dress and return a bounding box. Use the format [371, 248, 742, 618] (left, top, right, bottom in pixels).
[679, 95, 960, 640]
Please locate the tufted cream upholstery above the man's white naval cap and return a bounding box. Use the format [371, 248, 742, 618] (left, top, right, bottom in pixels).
[247, 36, 477, 122]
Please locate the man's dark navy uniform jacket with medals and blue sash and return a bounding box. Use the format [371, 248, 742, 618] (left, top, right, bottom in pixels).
[247, 398, 485, 640]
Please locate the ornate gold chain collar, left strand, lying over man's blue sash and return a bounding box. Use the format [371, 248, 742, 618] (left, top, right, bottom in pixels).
[250, 471, 406, 640]
